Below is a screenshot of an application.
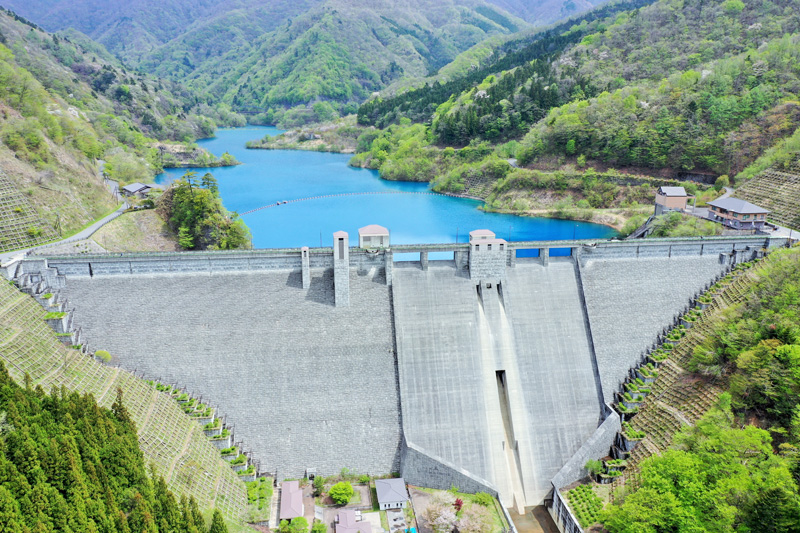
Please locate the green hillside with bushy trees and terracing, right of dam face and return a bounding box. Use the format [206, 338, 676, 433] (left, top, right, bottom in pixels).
[604, 248, 800, 533]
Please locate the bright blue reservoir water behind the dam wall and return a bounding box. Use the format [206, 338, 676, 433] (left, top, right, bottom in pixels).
[156, 126, 616, 248]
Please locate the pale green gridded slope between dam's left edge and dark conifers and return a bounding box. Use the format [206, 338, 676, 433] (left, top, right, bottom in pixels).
[0, 282, 247, 519]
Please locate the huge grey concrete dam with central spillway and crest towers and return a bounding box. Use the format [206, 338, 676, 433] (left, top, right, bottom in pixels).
[5, 231, 786, 509]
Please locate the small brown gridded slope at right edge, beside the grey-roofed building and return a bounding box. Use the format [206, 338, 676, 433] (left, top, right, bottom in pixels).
[734, 158, 800, 229]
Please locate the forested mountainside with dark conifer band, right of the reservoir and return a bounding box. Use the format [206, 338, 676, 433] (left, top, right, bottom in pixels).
[356, 0, 800, 190]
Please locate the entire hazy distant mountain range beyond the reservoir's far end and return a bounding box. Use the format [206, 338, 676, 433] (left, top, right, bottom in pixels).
[10, 0, 526, 122]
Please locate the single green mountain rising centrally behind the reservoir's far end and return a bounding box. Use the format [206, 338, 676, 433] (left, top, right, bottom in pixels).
[208, 0, 524, 121]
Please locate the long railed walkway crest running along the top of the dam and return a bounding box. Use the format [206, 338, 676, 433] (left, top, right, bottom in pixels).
[0, 236, 789, 285]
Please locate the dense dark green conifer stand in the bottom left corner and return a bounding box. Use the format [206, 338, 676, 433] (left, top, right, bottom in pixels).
[0, 363, 227, 533]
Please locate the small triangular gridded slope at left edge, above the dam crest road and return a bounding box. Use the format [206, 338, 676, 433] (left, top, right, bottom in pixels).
[0, 171, 57, 252]
